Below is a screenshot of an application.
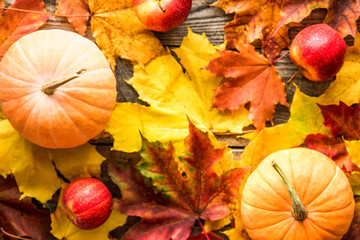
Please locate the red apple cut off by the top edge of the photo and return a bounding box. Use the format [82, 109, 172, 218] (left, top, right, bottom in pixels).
[133, 0, 192, 32]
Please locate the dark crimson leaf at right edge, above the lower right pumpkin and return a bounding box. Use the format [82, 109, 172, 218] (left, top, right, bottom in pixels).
[319, 101, 360, 140]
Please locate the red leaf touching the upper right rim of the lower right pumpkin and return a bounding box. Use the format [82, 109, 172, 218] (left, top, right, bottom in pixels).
[304, 134, 360, 172]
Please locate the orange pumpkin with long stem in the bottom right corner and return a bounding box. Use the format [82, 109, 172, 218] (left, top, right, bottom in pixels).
[241, 148, 355, 240]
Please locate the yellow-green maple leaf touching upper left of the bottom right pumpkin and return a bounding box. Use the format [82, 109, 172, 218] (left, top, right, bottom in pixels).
[241, 88, 330, 166]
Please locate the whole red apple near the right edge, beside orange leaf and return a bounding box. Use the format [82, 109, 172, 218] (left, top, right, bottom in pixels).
[290, 24, 346, 81]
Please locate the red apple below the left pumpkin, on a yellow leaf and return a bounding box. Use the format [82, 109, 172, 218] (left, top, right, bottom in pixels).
[62, 178, 112, 229]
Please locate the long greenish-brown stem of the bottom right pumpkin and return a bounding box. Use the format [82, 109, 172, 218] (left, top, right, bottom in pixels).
[271, 161, 308, 221]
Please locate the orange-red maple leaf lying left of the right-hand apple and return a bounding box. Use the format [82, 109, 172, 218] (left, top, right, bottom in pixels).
[205, 42, 288, 129]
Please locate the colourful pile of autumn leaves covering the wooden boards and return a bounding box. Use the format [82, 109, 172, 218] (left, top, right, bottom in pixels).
[0, 0, 360, 240]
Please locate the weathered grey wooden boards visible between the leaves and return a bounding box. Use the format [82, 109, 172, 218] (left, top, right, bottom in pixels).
[32, 0, 353, 159]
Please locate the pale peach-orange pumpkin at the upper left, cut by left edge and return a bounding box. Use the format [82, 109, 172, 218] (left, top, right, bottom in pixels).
[0, 30, 116, 148]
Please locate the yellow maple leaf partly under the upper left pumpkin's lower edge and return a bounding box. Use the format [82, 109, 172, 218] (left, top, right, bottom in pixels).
[0, 120, 104, 202]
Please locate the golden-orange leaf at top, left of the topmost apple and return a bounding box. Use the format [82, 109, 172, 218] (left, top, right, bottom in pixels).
[89, 0, 168, 69]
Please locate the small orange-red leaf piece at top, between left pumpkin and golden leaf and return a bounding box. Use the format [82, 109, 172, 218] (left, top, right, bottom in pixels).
[55, 0, 90, 36]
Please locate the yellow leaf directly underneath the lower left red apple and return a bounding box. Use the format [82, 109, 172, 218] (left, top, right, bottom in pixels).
[51, 186, 127, 240]
